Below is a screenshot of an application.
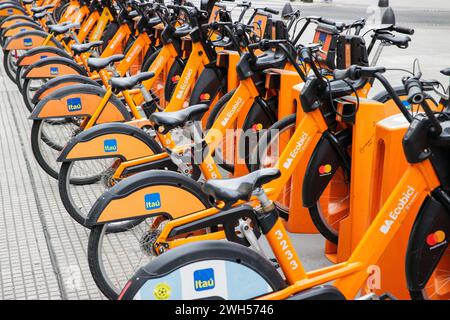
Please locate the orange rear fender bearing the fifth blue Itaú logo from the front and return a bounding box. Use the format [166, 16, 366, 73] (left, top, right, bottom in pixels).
[22, 57, 88, 78]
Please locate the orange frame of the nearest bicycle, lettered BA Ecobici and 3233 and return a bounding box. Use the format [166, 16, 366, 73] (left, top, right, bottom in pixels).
[261, 160, 440, 299]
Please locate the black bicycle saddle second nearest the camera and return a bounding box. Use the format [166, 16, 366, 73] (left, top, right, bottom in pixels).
[150, 104, 209, 132]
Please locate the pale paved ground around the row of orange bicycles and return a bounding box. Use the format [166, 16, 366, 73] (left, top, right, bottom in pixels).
[0, 0, 450, 299]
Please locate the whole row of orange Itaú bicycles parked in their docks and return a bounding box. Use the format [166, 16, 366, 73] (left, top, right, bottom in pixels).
[0, 0, 450, 300]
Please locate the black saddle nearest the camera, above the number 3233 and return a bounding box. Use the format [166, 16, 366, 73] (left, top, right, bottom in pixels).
[202, 168, 281, 204]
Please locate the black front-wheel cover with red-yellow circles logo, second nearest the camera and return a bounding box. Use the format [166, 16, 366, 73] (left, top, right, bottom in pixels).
[302, 132, 350, 208]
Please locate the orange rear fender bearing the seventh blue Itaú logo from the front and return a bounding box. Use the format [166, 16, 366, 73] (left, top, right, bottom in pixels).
[3, 30, 63, 51]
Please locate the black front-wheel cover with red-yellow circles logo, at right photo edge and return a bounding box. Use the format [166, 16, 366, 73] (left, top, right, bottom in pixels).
[406, 196, 450, 291]
